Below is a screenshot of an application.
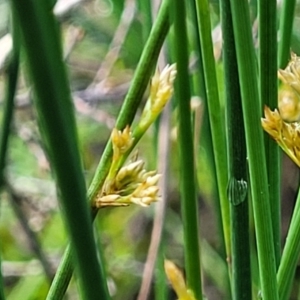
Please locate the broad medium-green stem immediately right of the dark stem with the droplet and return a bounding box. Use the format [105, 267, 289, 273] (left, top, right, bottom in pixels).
[230, 0, 278, 300]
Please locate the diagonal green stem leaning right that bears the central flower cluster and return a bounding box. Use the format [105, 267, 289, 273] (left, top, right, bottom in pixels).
[47, 0, 170, 300]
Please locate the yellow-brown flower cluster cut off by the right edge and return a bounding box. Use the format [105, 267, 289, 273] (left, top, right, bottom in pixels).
[261, 53, 300, 167]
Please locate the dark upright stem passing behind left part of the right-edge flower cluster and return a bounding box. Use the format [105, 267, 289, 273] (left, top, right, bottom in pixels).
[258, 0, 281, 269]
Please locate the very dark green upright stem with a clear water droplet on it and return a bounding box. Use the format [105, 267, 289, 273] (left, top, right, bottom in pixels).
[221, 0, 252, 300]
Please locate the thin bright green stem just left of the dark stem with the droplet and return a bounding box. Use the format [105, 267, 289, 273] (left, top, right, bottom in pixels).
[196, 0, 231, 257]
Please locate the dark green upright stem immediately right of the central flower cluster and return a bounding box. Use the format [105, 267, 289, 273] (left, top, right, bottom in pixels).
[173, 1, 202, 300]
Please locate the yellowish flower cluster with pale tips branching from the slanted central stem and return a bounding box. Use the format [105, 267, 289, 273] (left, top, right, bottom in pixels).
[93, 65, 176, 208]
